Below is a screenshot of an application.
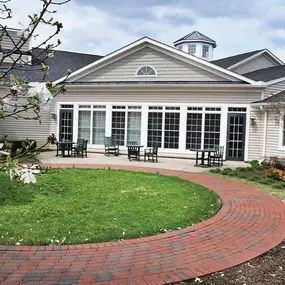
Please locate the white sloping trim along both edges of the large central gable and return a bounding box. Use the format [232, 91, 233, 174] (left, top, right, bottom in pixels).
[55, 37, 258, 85]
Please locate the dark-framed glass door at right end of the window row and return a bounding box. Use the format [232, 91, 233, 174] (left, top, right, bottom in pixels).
[226, 113, 246, 161]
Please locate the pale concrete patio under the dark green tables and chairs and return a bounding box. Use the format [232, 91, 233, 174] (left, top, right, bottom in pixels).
[39, 151, 249, 173]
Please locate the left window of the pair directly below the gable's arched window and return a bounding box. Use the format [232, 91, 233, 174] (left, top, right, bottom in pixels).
[147, 112, 163, 147]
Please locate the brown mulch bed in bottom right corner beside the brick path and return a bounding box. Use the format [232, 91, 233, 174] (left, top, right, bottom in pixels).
[176, 240, 285, 285]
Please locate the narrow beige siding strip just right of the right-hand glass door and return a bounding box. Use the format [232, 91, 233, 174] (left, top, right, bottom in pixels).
[248, 110, 264, 160]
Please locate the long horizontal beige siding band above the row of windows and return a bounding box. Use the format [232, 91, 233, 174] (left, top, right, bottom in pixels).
[49, 87, 260, 138]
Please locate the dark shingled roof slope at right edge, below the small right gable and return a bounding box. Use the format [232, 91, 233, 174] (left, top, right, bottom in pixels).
[243, 65, 285, 82]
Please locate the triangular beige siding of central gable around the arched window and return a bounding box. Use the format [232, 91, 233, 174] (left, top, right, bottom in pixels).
[77, 47, 231, 82]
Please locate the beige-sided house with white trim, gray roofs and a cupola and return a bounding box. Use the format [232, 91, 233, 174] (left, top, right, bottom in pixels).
[0, 31, 285, 160]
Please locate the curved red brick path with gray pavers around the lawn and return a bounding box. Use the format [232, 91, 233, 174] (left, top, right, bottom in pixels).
[0, 165, 285, 285]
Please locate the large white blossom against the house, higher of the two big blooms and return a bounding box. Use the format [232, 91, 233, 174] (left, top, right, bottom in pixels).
[28, 82, 53, 109]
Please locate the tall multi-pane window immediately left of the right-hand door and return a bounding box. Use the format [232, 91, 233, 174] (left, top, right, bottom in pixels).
[204, 114, 221, 148]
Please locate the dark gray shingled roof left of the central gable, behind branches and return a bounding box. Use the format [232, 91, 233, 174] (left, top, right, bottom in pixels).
[0, 49, 102, 82]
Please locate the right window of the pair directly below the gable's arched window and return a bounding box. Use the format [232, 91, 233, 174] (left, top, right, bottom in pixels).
[164, 112, 180, 149]
